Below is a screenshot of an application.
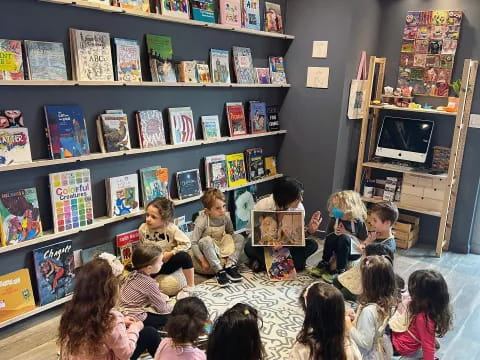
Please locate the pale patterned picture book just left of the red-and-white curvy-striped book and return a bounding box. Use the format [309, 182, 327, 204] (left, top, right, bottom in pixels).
[137, 110, 167, 149]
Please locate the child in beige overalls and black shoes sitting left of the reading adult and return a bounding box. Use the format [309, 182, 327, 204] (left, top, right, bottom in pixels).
[192, 189, 244, 287]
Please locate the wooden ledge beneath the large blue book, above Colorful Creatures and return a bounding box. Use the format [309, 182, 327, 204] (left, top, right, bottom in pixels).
[0, 130, 287, 172]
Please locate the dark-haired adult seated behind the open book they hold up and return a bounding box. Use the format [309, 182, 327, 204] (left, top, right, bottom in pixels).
[245, 177, 322, 272]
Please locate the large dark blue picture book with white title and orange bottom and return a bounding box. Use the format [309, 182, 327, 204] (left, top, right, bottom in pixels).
[44, 105, 90, 159]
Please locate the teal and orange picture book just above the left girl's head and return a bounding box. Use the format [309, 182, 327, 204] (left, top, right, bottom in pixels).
[139, 166, 170, 207]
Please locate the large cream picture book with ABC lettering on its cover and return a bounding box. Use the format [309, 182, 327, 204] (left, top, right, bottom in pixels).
[70, 29, 114, 81]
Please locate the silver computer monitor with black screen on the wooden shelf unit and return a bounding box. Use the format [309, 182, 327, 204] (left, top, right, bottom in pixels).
[375, 116, 434, 163]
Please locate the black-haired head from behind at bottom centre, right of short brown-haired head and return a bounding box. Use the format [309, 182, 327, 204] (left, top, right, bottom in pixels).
[207, 303, 265, 360]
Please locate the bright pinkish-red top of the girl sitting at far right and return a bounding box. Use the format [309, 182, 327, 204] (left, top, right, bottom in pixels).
[392, 313, 435, 360]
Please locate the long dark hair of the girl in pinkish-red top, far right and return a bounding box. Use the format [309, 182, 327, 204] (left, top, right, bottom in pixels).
[408, 270, 452, 336]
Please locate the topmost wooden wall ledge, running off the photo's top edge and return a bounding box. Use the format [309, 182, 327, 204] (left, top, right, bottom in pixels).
[40, 0, 295, 40]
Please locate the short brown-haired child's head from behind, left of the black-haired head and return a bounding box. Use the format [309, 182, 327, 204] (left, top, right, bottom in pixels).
[165, 296, 208, 344]
